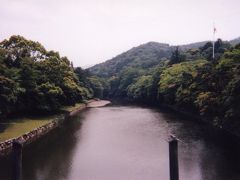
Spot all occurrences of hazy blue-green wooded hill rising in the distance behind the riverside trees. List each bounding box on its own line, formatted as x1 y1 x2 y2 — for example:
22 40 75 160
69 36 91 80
89 42 172 77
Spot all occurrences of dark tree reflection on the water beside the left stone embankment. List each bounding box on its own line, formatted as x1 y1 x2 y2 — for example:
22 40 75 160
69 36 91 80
0 109 86 180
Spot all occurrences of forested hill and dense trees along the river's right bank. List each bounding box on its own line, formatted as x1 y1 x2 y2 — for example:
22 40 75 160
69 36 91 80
90 39 240 132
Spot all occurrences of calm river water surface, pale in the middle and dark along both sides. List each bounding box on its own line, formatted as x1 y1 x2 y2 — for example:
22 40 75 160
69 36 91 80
0 106 240 180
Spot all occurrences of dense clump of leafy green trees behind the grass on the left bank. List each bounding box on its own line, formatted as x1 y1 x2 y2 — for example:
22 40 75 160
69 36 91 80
0 36 94 117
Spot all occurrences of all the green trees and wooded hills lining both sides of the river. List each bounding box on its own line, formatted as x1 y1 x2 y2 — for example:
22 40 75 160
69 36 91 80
0 36 240 135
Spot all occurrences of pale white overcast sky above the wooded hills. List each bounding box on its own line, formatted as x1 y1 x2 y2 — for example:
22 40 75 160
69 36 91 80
0 0 240 67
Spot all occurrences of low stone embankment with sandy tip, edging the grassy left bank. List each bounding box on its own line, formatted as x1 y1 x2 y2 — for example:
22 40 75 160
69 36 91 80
0 100 110 156
